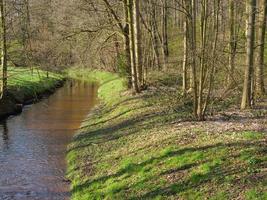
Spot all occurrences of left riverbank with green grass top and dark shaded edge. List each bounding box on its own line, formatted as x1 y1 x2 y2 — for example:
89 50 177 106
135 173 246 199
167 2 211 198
0 68 64 120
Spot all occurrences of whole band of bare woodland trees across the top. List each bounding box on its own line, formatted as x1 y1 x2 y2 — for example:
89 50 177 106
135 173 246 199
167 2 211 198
1 0 267 120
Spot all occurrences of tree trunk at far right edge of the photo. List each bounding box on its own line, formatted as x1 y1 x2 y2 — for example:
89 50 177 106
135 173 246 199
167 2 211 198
256 0 267 96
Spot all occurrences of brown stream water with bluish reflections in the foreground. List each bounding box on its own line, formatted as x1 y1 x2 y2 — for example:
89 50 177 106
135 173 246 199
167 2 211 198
0 81 97 200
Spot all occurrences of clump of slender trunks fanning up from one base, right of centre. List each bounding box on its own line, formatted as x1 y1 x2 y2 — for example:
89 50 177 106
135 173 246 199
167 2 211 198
180 0 221 120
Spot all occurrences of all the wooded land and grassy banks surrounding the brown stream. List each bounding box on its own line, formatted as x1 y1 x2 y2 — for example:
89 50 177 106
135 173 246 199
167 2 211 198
0 0 267 200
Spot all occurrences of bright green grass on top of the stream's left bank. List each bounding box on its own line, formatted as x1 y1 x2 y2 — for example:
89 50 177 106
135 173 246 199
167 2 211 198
8 67 63 97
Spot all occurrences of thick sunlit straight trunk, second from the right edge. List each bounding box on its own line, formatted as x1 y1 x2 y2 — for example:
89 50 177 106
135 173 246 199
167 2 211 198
241 0 256 109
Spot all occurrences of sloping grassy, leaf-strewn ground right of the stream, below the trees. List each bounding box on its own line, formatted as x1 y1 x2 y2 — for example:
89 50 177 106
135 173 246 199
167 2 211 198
67 70 267 200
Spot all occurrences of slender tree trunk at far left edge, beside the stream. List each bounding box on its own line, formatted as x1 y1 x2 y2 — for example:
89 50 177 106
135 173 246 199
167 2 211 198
0 0 7 98
